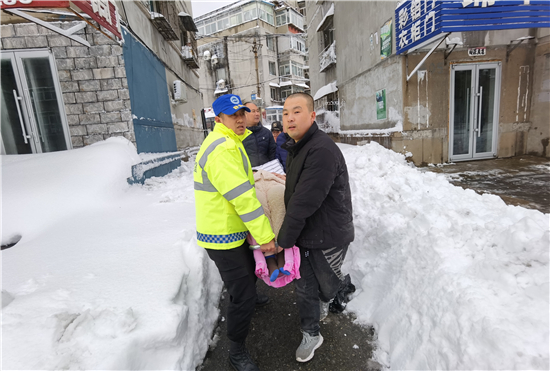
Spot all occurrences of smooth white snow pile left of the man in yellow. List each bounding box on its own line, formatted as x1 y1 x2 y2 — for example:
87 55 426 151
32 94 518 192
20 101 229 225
2 138 221 370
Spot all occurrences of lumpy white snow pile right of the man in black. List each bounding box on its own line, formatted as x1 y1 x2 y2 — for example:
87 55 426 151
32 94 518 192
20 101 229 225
342 143 549 370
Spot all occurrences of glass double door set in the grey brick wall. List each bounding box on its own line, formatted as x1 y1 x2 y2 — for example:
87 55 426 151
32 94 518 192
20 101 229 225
1 51 71 154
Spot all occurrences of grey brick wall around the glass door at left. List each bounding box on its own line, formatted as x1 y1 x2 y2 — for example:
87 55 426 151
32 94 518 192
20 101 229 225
0 22 135 148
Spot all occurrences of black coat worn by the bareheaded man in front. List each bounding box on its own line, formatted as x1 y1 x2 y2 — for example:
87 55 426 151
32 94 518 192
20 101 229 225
278 122 355 249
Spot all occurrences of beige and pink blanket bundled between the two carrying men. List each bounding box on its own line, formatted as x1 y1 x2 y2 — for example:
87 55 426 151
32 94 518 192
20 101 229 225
247 170 300 287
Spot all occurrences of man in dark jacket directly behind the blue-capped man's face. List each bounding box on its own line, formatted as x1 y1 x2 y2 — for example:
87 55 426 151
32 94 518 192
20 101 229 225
243 102 277 167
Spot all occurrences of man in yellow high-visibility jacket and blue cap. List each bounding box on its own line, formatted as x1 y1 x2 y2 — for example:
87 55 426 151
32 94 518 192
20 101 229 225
194 94 281 370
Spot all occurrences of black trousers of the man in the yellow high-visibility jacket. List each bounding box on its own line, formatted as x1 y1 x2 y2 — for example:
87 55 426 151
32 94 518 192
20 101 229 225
206 241 257 343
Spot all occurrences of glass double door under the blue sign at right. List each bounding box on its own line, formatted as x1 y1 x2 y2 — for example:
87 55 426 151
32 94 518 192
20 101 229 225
449 63 500 161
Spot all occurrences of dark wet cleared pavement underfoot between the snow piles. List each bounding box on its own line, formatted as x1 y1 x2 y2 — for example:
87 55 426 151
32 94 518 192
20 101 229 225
197 280 380 371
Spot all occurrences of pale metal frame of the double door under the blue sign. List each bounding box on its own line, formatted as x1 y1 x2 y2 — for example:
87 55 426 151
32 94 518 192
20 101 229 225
449 62 501 161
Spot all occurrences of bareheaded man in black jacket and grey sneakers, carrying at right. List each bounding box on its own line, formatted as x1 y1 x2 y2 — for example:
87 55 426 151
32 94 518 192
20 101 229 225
278 93 354 362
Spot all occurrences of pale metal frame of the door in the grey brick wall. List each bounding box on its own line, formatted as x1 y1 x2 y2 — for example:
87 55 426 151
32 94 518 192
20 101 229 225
0 49 73 154
